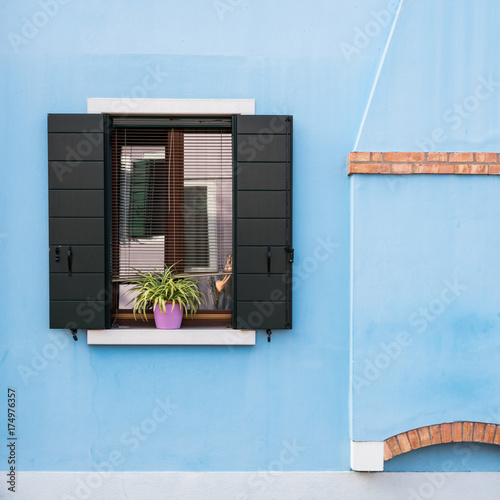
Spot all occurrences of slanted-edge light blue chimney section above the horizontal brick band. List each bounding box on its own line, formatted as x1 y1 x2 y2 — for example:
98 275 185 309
356 0 500 152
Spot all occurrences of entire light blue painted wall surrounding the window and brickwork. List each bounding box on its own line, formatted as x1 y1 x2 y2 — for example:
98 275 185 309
0 0 500 471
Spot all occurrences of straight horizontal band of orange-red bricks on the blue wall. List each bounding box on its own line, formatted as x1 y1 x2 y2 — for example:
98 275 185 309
348 152 500 175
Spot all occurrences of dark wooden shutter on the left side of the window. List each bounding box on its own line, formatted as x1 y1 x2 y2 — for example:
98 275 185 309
48 114 110 329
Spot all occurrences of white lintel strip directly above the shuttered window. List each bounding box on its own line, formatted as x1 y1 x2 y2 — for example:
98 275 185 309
87 97 255 116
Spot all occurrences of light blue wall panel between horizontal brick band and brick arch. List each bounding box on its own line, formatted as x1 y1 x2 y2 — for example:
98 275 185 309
353 175 500 441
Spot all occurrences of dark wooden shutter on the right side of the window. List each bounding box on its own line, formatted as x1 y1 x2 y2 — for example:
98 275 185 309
233 116 293 329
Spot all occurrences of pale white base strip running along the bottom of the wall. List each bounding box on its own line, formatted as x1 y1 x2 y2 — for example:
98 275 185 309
5 472 500 500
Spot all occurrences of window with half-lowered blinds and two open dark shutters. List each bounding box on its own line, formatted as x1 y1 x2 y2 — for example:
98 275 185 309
48 100 293 329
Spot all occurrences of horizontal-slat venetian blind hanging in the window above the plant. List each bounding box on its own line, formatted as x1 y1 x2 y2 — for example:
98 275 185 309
111 117 232 282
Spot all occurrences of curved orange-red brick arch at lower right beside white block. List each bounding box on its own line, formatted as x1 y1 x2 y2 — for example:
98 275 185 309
384 422 500 461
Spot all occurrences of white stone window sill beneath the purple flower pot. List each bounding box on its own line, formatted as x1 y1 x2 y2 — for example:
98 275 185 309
87 327 255 346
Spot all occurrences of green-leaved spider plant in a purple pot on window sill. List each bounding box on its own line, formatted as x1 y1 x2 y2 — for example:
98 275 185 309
126 264 206 330
